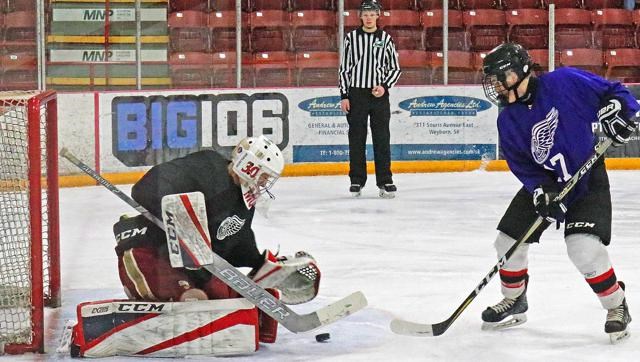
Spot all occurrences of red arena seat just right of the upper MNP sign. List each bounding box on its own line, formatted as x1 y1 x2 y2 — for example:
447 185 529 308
169 10 211 52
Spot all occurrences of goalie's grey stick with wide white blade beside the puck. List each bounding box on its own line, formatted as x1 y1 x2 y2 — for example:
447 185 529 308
60 148 367 333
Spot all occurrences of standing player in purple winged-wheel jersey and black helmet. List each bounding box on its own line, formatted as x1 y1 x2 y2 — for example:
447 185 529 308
482 43 640 343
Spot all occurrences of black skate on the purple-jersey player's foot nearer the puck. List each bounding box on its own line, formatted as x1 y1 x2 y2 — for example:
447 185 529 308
482 275 529 331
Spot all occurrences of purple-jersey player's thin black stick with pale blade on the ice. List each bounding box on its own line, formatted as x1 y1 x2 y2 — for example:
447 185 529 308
391 138 612 337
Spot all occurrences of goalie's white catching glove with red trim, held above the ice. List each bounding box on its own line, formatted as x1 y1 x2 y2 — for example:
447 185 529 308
248 250 321 304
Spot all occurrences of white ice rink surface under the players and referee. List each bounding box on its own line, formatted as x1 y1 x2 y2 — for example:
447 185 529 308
6 171 640 362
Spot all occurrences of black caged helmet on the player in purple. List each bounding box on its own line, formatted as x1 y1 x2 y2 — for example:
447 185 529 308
482 43 535 105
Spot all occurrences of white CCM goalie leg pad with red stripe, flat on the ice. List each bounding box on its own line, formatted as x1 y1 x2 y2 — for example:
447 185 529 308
70 298 258 357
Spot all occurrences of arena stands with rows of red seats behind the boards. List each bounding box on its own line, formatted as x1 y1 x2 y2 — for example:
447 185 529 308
0 0 640 90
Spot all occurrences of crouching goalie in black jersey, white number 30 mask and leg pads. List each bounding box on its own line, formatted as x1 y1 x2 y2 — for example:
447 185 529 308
72 136 320 357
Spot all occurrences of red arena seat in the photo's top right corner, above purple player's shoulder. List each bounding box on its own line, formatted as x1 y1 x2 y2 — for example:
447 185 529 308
592 9 636 49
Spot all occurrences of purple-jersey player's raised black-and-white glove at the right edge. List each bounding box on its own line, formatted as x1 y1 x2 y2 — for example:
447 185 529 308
598 97 636 146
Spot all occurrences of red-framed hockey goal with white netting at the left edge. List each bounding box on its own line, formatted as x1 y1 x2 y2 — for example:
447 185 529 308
0 91 60 354
